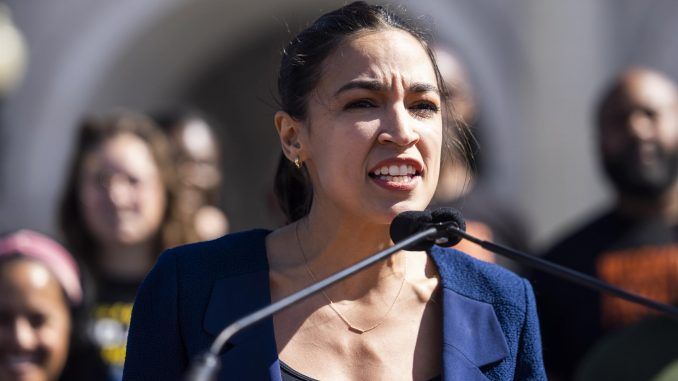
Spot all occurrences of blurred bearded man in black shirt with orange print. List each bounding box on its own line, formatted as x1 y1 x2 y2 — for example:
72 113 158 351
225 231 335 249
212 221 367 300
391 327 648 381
535 68 678 379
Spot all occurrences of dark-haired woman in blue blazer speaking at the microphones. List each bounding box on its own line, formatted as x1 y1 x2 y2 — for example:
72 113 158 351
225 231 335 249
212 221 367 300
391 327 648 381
125 2 545 380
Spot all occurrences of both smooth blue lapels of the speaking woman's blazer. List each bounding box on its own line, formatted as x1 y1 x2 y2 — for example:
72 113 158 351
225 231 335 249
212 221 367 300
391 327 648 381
203 245 509 381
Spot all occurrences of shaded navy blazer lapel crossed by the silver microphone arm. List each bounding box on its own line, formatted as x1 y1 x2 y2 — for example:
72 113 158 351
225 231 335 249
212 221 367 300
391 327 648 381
203 271 281 380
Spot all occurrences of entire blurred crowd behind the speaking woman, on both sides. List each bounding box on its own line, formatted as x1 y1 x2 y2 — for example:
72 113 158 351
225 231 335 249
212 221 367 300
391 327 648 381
0 2 678 380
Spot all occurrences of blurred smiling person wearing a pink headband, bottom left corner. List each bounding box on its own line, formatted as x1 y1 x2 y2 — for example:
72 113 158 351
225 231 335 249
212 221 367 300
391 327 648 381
0 230 104 381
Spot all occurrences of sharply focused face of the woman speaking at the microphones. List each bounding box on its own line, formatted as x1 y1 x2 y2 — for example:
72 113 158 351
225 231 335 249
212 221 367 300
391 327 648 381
300 30 442 224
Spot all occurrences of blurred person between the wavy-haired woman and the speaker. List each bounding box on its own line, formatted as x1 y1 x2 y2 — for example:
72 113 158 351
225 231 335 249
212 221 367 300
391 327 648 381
154 112 228 242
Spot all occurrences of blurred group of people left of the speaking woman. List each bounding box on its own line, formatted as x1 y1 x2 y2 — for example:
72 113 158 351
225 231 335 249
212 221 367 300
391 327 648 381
0 110 228 380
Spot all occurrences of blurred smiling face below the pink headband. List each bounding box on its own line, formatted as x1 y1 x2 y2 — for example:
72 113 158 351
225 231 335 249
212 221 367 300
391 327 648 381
0 259 71 381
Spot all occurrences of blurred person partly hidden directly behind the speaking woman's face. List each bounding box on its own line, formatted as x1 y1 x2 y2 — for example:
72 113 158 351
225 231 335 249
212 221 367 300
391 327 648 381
431 45 527 269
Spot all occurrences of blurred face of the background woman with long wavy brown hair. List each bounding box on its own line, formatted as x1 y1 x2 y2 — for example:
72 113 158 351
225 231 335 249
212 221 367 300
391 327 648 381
79 133 166 247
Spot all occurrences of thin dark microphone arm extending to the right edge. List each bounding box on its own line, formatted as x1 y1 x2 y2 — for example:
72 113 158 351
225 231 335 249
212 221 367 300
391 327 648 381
444 223 678 318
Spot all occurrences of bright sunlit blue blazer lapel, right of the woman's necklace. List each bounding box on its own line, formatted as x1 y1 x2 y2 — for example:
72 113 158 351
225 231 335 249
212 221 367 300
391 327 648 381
443 288 509 380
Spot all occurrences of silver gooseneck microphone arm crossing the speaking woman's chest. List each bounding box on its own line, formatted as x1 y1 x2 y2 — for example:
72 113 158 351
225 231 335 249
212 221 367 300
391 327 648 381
186 225 444 381
